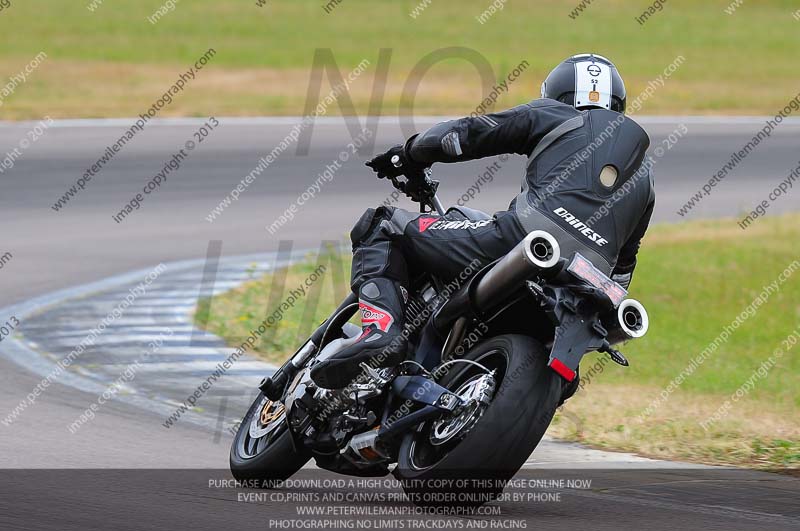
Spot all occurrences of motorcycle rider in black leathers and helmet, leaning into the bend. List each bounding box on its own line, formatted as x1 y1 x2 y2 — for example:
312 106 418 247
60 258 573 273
311 54 655 389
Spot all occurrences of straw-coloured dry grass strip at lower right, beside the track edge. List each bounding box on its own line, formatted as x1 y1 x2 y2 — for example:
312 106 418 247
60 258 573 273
549 382 800 469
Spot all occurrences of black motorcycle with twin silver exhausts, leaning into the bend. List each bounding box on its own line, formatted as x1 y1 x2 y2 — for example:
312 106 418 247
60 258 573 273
230 160 649 505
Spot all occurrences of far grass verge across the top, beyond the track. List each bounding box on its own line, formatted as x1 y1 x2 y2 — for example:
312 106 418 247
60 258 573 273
0 0 799 119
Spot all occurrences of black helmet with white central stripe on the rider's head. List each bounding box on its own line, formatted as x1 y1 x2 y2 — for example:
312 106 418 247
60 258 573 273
542 53 626 113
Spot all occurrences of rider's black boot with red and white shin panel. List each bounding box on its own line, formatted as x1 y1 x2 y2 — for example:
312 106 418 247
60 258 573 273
311 278 408 389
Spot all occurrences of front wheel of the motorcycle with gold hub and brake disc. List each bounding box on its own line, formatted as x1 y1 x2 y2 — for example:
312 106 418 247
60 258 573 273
230 393 310 482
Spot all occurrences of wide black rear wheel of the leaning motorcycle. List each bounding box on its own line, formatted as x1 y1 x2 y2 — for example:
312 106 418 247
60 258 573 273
394 335 564 505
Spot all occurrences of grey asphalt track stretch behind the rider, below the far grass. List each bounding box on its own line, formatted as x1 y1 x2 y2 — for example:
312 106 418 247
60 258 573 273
0 117 800 306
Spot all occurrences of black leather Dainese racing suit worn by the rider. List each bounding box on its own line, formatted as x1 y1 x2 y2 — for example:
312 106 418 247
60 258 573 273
351 99 655 300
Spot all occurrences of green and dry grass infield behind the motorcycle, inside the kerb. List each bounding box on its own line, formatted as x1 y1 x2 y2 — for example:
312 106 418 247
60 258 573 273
197 214 800 469
